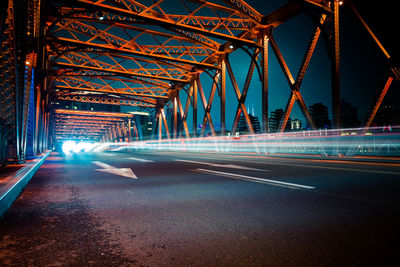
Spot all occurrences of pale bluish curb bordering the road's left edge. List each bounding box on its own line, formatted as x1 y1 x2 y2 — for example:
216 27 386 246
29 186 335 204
0 151 51 217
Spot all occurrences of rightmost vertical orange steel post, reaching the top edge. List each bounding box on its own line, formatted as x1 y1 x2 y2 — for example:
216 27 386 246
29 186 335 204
331 0 340 129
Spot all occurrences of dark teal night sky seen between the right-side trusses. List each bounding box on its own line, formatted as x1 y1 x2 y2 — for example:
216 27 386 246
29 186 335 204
222 0 399 130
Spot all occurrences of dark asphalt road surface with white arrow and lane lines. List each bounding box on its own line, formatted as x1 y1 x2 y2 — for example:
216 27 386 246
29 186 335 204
0 151 400 266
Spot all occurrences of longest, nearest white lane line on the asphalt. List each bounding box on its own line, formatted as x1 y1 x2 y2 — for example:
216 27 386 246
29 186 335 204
193 168 315 189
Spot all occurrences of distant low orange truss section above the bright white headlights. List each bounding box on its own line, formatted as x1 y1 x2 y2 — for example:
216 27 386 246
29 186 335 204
52 109 137 142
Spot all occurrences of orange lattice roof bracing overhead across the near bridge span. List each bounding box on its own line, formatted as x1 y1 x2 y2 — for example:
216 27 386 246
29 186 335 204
43 0 261 111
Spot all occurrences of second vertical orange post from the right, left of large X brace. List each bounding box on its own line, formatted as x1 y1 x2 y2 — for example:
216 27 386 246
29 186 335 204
261 29 269 133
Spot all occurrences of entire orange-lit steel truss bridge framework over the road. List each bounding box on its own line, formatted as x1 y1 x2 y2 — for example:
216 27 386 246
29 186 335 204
0 0 400 163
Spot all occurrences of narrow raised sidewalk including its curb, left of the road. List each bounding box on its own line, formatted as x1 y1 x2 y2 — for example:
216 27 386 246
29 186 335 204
0 151 51 217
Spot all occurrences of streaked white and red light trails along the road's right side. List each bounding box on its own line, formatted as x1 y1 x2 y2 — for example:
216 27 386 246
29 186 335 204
109 126 400 157
